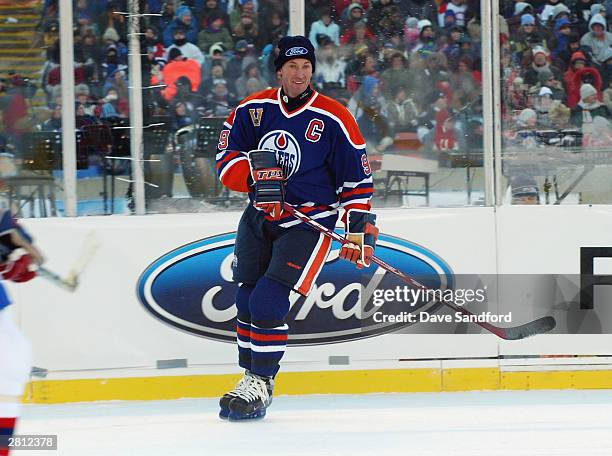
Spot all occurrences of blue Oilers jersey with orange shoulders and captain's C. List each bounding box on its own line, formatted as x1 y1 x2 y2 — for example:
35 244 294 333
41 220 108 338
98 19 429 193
217 89 373 228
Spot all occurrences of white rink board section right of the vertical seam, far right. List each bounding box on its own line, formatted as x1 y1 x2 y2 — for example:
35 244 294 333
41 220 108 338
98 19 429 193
496 205 612 355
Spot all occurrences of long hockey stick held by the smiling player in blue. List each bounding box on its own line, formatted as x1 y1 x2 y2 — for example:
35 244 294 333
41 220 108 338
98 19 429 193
283 203 557 340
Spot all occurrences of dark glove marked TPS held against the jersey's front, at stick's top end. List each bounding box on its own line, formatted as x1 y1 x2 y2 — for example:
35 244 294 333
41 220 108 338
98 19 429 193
249 150 285 220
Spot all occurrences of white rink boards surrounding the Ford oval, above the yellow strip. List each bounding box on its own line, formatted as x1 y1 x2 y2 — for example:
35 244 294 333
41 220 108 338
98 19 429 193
10 206 612 378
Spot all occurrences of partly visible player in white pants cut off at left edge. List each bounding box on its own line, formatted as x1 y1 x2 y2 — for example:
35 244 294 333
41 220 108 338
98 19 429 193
0 210 42 456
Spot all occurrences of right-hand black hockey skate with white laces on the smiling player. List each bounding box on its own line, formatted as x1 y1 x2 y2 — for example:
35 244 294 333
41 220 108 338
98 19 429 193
228 372 274 421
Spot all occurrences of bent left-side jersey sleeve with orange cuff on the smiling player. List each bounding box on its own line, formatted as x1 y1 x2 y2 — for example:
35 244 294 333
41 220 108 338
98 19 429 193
217 108 254 193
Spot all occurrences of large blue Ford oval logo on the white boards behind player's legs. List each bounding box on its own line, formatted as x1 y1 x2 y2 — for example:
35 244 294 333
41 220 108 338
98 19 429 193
138 233 453 345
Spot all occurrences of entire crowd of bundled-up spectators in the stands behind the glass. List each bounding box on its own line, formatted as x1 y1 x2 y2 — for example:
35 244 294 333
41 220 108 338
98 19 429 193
0 0 612 166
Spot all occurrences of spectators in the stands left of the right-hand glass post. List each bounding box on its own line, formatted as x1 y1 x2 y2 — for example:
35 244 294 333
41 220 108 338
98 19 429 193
10 0 482 157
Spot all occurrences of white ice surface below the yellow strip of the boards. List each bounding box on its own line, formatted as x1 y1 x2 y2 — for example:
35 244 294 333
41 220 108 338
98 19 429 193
16 390 612 456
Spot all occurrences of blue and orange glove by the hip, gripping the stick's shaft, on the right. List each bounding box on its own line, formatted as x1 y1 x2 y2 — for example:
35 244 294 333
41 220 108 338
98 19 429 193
340 209 378 269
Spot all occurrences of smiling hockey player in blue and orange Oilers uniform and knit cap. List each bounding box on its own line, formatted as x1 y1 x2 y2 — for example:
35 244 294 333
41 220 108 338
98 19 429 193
217 36 376 420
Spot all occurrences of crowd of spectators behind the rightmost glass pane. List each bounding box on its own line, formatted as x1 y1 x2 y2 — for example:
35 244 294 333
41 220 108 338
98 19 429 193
500 0 612 147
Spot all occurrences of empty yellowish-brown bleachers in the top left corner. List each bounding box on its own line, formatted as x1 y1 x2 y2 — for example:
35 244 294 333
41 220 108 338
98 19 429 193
0 0 48 108
